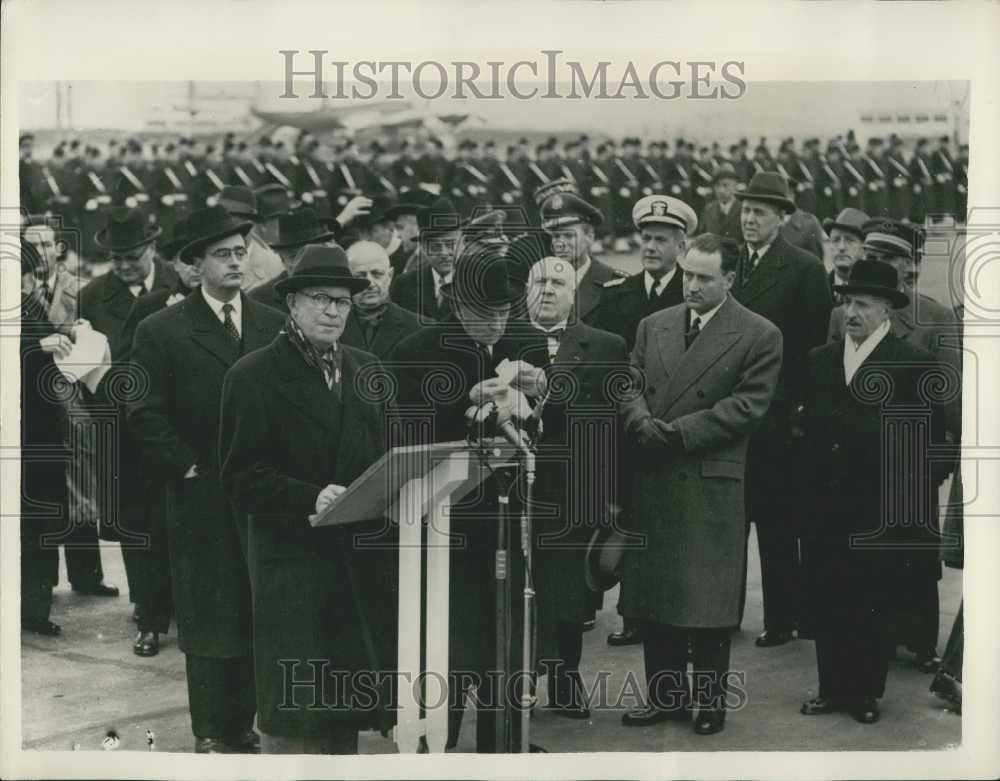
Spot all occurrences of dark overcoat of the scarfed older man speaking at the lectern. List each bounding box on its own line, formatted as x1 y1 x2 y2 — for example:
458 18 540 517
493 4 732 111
219 333 396 736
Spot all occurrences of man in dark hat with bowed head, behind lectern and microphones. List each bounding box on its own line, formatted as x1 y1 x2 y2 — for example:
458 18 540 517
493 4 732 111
388 242 540 753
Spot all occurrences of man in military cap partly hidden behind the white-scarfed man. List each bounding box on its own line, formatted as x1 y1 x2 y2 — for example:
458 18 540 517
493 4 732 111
830 219 962 673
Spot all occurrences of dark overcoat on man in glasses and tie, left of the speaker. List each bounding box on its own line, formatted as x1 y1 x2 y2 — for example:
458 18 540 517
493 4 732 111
128 289 284 658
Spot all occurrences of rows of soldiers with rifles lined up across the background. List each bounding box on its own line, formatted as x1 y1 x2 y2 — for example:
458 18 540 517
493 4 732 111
20 132 968 272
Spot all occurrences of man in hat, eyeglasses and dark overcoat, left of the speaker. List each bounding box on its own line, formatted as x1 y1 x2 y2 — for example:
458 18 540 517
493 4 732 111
128 205 283 753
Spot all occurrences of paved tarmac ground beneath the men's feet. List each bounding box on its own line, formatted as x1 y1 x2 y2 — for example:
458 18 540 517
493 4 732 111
22 237 961 753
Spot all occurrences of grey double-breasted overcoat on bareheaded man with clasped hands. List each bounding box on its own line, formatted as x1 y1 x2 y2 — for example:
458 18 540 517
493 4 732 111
622 296 782 628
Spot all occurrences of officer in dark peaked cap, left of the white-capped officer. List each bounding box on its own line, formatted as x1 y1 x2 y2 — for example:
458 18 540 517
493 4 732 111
541 192 628 325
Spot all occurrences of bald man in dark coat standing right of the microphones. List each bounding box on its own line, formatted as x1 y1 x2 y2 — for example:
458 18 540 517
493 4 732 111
515 257 628 719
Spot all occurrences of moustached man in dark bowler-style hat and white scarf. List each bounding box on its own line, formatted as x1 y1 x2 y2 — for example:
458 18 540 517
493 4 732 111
801 260 948 724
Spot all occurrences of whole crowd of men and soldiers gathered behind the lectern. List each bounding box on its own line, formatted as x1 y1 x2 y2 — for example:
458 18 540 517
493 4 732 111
21 123 964 753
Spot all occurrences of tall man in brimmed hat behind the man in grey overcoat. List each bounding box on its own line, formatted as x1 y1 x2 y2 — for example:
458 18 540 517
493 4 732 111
733 171 832 647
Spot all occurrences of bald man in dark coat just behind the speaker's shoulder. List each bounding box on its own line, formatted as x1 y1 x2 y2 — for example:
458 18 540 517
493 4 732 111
340 241 420 358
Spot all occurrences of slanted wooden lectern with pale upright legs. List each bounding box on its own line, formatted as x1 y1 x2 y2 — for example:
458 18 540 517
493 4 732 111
312 438 517 754
